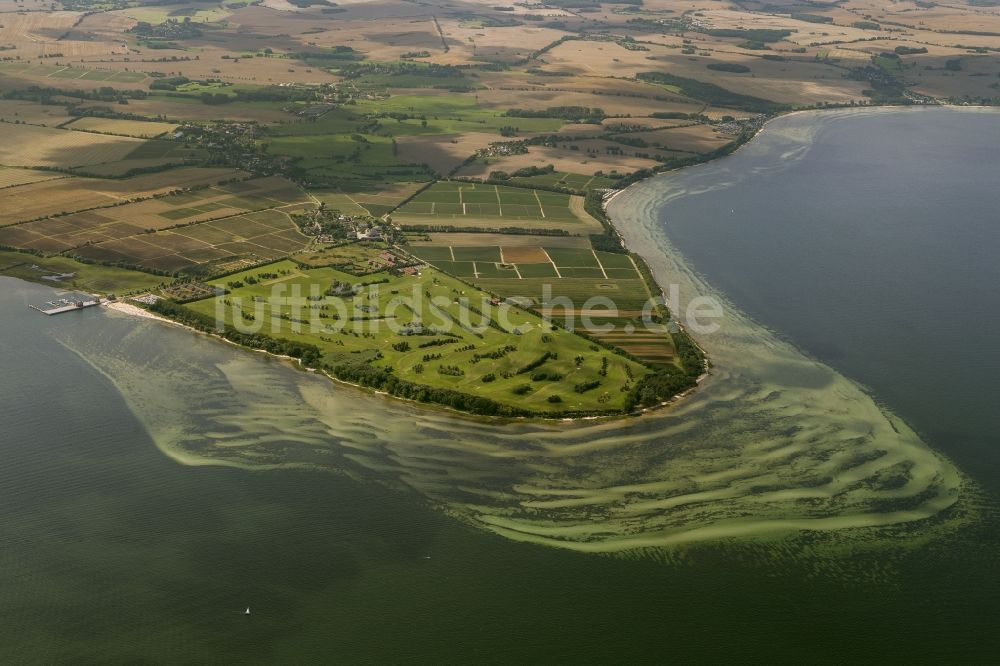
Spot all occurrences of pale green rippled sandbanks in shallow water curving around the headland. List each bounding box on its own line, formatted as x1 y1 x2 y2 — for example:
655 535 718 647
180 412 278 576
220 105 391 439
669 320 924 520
43 106 978 557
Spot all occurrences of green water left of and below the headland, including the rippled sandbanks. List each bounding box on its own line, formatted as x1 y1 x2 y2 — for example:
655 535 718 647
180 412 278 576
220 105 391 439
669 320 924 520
0 106 1000 663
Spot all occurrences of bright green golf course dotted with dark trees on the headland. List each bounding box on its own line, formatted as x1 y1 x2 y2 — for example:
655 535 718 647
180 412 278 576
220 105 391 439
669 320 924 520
188 253 648 412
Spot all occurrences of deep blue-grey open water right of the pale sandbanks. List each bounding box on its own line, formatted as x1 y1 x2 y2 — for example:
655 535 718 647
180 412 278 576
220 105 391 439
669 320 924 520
658 108 1000 488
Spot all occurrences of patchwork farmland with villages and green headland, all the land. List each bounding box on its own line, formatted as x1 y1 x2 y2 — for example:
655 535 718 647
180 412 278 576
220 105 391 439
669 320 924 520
0 2 1000 418
